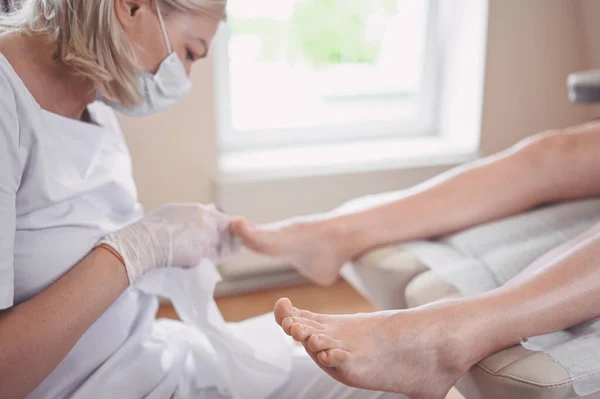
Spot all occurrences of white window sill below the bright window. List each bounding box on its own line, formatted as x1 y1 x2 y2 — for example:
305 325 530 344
218 137 479 183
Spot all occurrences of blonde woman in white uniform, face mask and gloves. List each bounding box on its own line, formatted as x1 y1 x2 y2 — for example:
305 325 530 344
0 0 406 399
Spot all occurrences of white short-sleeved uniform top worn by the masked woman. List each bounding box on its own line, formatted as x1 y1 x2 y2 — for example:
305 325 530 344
0 54 166 398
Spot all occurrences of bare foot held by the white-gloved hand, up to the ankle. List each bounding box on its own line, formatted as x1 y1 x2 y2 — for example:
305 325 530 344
232 219 353 286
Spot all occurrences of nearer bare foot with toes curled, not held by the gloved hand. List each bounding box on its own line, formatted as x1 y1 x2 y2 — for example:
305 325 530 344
275 298 471 399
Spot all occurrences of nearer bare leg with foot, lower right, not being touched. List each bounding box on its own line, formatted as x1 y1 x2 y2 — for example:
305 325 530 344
275 225 600 399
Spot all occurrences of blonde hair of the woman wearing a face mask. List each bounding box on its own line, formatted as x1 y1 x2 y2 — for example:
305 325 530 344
0 0 227 106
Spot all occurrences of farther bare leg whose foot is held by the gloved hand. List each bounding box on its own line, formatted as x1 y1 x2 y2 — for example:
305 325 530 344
233 124 600 285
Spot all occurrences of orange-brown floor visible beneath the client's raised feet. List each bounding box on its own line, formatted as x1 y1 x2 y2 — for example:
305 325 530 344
158 282 463 399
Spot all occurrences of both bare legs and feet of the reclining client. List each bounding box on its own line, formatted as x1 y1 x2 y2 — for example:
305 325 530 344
235 123 600 399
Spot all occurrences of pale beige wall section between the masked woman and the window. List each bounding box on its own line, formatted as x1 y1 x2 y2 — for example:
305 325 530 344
121 61 217 210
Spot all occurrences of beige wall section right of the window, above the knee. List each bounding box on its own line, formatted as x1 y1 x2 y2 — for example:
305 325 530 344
481 0 589 154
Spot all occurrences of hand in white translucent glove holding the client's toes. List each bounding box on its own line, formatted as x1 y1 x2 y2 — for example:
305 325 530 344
98 204 241 285
